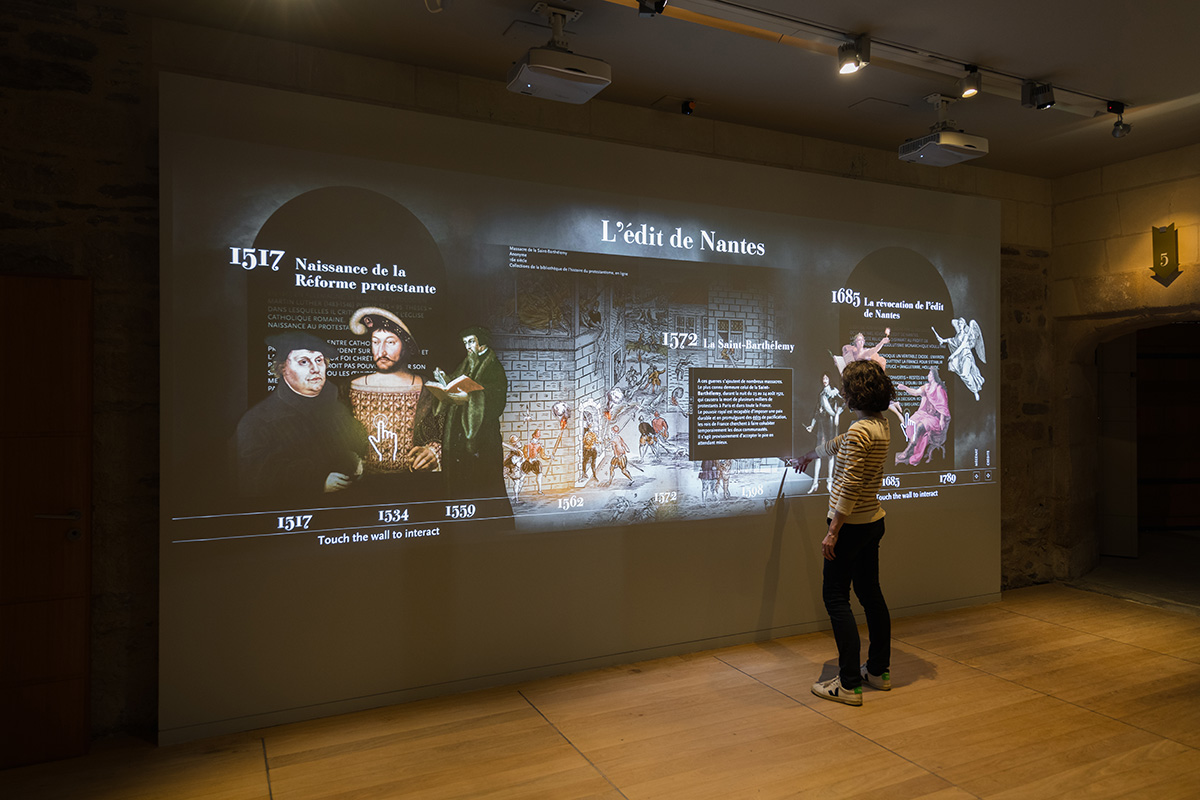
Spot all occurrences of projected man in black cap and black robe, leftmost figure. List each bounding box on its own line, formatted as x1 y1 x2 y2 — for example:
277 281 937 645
236 331 367 498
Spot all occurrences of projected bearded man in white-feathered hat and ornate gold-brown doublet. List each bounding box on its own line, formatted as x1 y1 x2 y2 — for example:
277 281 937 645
350 307 442 475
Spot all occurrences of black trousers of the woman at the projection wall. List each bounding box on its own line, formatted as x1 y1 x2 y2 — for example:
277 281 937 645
821 517 892 688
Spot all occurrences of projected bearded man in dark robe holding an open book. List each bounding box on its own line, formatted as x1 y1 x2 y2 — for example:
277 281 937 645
430 327 511 513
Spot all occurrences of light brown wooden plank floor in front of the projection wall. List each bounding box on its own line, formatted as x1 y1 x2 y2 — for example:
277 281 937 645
0 585 1200 800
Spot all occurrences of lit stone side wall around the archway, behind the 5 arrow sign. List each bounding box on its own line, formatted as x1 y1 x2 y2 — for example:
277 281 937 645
1046 145 1200 578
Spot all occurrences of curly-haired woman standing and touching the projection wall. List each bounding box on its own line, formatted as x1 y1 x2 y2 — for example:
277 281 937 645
797 361 895 705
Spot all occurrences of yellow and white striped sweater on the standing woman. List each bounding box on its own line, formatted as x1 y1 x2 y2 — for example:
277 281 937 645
816 416 892 524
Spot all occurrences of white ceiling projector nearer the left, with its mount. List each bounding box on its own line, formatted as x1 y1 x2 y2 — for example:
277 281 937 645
509 2 612 104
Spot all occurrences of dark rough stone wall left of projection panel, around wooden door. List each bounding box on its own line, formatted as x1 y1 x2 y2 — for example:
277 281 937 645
0 1 158 733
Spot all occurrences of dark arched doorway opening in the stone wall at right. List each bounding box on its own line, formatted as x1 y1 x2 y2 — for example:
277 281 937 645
1082 321 1200 613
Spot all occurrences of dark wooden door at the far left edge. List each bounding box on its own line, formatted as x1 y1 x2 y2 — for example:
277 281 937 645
0 276 91 769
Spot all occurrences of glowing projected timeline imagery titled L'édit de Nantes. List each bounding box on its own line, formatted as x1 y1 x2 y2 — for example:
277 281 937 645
166 122 996 546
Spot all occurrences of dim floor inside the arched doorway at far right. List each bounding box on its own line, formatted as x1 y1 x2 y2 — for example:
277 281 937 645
1067 531 1200 616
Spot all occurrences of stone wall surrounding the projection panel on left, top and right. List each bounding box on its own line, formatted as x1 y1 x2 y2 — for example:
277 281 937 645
0 0 1152 734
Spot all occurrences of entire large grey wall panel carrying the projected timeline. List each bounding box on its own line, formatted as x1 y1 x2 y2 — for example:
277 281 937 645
161 74 1000 740
